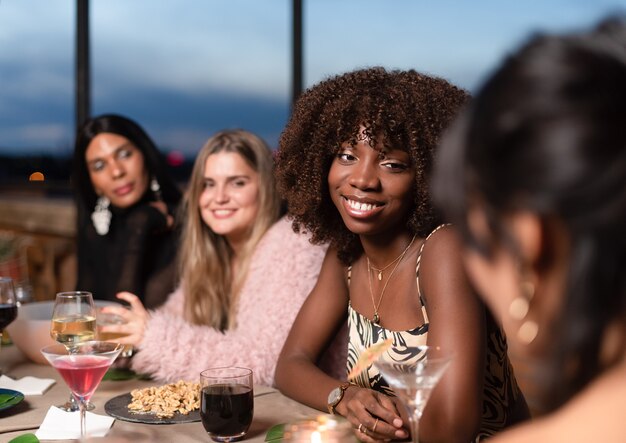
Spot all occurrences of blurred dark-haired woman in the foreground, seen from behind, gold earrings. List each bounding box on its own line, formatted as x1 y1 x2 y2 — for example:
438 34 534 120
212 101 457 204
434 16 626 443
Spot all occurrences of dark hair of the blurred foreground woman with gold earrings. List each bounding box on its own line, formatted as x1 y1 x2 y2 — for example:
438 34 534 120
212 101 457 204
434 16 626 406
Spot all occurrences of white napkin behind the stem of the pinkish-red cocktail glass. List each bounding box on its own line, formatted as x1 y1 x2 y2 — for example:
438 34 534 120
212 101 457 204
35 406 115 440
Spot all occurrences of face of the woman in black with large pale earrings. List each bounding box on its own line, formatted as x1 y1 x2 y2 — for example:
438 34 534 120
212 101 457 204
85 132 149 208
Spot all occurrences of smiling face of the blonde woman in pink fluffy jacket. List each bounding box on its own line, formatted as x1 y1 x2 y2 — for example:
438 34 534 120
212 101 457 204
199 151 259 247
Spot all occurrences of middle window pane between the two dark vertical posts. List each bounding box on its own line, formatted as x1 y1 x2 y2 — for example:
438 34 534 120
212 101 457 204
91 0 291 159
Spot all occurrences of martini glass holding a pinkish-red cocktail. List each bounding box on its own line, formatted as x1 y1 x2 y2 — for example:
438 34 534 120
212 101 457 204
41 341 124 438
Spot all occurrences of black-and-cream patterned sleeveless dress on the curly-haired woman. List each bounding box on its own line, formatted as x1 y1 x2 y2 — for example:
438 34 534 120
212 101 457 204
347 225 525 442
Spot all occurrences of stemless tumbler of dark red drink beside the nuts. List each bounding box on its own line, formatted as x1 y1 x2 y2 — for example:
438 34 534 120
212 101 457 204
200 367 254 442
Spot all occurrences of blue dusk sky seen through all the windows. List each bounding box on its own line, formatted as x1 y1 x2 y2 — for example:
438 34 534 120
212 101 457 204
0 0 626 157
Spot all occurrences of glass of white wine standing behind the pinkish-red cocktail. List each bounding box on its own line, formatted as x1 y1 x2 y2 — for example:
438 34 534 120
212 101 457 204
50 291 96 411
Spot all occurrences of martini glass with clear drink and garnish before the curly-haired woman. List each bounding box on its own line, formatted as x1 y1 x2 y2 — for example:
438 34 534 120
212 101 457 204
374 346 452 443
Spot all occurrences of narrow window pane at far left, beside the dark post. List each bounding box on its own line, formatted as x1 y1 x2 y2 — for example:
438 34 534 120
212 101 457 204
0 0 75 187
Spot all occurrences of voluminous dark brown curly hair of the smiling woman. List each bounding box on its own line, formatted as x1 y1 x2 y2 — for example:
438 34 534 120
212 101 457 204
276 67 469 264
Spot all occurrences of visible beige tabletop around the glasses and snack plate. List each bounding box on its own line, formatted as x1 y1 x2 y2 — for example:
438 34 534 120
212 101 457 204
0 345 323 443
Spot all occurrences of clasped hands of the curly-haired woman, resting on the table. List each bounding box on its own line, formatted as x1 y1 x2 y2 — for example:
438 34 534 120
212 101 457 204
335 385 409 443
